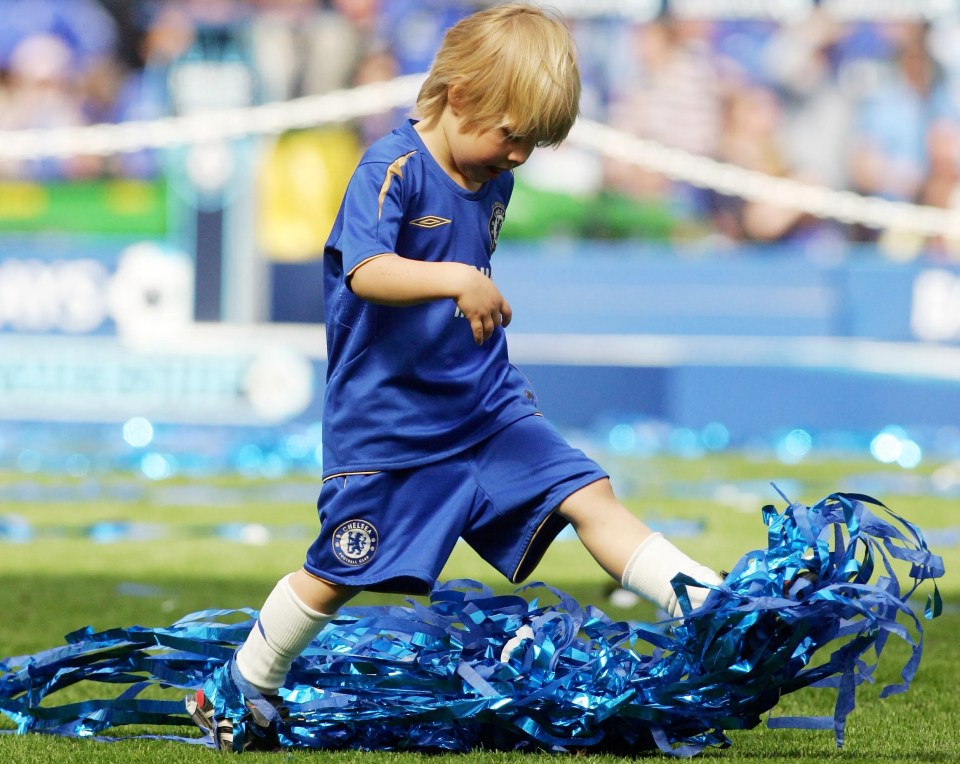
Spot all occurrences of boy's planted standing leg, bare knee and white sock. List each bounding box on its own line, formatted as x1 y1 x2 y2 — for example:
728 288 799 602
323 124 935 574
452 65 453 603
236 570 359 695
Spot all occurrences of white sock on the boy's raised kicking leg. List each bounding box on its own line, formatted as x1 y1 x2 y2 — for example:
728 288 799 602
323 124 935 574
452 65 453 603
622 533 722 617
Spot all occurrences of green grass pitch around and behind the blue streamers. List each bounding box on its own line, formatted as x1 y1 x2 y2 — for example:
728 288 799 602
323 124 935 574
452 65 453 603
0 454 960 764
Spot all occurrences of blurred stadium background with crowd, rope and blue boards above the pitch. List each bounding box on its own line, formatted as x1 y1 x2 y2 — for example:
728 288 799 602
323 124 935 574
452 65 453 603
0 0 960 484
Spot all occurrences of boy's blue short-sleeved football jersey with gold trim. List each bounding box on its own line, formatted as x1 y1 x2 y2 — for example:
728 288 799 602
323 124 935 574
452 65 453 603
323 121 536 477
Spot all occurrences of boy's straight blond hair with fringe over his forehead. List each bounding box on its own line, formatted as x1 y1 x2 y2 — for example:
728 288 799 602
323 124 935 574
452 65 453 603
416 4 580 146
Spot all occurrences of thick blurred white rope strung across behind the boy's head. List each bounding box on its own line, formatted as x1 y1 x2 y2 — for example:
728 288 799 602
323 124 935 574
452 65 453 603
0 74 960 238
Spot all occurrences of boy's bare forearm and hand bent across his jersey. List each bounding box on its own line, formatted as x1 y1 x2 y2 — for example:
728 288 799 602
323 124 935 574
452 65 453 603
350 253 513 345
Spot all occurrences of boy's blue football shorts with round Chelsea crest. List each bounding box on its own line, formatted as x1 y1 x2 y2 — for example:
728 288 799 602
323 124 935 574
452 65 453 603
304 415 607 594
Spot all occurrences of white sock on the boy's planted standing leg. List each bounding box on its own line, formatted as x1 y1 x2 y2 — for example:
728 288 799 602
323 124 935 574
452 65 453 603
236 573 333 695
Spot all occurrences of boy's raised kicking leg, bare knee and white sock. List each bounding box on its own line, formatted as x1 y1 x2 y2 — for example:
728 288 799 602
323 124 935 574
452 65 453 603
558 479 720 615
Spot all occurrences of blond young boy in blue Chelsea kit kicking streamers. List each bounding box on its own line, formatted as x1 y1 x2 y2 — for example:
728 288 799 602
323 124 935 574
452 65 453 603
187 5 719 750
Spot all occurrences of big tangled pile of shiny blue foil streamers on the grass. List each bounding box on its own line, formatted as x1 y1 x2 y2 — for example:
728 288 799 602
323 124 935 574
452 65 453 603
0 493 943 756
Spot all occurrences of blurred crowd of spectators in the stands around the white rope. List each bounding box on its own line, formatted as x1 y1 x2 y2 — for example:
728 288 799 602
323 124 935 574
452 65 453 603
0 0 960 252
